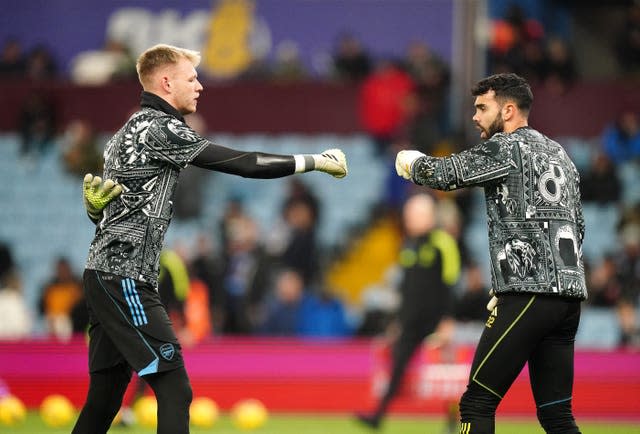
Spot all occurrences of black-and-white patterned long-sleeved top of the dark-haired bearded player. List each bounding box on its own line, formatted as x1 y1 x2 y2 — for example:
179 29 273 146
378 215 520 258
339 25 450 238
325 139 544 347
412 127 587 299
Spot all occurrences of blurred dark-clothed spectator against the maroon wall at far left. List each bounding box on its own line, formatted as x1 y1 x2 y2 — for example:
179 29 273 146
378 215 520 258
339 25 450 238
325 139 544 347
18 92 56 157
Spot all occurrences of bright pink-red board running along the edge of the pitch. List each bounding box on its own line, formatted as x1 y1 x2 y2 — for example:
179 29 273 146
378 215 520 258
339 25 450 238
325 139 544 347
0 338 640 419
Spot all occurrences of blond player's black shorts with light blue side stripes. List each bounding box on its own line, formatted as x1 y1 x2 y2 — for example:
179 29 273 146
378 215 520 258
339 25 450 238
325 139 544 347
83 270 184 375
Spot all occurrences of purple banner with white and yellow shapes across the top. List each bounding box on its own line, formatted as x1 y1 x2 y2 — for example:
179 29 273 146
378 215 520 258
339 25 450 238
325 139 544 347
0 0 453 77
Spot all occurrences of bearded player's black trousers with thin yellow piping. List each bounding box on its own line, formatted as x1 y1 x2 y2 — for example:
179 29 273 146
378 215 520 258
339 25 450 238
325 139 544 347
460 294 580 434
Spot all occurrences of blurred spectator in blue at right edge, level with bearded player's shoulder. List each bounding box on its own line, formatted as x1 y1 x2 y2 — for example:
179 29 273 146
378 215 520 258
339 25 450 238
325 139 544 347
602 110 640 165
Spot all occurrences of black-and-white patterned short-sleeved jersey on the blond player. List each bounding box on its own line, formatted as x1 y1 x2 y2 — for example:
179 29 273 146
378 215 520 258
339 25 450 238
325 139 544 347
86 92 210 286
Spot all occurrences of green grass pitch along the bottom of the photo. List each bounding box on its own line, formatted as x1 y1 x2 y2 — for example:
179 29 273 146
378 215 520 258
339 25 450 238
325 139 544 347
5 412 640 434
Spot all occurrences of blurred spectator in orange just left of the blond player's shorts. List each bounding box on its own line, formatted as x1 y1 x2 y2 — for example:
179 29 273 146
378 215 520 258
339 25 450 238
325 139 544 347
39 257 83 340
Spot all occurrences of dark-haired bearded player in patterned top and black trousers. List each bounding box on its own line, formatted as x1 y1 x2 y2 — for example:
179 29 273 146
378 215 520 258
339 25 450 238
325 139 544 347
396 73 587 434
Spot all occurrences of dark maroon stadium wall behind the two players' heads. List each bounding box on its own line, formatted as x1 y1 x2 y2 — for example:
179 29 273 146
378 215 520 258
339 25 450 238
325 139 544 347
0 80 640 138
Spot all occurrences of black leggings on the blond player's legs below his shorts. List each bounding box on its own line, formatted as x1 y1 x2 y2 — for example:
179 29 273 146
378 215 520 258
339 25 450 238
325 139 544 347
72 365 192 434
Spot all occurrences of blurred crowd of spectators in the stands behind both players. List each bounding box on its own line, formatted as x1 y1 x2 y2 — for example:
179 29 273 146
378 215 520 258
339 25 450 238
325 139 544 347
0 5 640 346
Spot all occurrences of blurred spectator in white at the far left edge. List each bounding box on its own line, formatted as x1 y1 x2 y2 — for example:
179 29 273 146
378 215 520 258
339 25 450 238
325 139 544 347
0 273 33 341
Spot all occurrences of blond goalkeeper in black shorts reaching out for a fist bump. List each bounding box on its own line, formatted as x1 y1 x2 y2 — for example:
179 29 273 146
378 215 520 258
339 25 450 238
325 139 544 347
73 45 347 434
